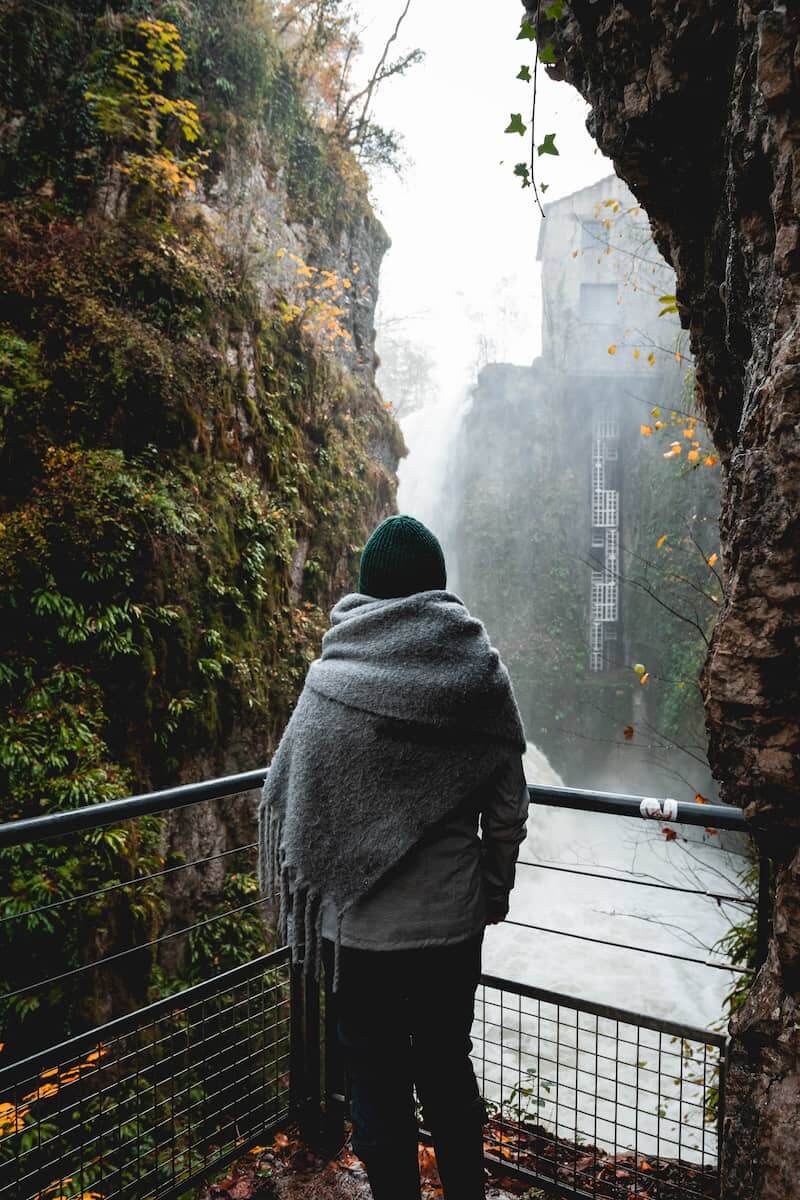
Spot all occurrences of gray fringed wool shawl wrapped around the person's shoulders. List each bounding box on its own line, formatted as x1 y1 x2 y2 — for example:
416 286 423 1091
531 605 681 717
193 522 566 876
259 590 525 991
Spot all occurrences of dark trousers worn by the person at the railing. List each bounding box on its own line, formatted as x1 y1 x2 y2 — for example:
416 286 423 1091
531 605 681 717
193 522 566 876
323 932 487 1200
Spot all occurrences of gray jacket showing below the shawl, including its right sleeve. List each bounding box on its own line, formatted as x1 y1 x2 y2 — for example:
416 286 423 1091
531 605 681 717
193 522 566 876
321 751 528 950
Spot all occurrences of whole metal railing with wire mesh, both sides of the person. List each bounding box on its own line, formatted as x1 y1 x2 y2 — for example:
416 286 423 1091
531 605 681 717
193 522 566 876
0 772 766 1200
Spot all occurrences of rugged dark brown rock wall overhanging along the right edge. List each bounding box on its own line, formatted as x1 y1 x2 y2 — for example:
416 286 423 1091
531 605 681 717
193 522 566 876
525 0 800 1200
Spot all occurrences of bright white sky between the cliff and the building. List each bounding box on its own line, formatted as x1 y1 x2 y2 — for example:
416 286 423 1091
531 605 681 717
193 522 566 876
355 0 613 392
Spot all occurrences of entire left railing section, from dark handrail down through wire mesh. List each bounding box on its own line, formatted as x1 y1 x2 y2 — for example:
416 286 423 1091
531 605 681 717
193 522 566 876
0 776 297 1200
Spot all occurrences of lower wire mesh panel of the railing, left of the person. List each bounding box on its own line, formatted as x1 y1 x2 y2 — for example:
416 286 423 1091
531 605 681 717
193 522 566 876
0 949 290 1200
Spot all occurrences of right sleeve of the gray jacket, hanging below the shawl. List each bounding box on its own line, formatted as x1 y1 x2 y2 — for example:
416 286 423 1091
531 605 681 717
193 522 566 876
481 754 528 910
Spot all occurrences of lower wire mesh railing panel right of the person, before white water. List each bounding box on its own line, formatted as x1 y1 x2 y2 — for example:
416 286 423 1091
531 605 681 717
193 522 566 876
473 976 726 1200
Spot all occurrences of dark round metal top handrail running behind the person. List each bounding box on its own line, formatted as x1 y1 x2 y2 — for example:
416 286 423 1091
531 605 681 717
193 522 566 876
0 767 750 850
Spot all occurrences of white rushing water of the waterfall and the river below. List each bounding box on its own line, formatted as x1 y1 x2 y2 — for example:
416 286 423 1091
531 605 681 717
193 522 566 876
399 396 742 1159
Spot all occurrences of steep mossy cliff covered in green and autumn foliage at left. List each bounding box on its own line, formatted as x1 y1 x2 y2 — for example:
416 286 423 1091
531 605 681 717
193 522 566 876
0 0 403 1043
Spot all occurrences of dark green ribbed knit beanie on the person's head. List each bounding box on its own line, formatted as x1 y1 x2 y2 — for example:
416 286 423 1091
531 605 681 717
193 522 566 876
359 516 447 600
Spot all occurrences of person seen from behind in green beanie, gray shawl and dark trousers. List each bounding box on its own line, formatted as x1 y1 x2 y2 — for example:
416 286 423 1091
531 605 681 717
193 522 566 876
259 516 528 1200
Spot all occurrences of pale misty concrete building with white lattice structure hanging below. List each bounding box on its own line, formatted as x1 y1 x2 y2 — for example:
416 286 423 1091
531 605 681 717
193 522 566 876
536 175 678 672
